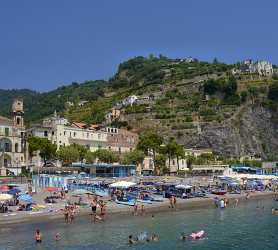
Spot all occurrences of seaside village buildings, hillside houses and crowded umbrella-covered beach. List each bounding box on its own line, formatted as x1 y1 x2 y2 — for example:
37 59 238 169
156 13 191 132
0 60 278 226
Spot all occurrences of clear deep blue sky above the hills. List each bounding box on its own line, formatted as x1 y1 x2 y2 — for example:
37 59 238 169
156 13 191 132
0 0 278 91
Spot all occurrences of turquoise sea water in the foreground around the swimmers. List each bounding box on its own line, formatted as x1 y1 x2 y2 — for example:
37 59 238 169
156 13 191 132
0 200 278 250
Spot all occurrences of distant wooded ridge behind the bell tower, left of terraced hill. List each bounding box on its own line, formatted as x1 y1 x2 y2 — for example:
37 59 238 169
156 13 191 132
0 81 107 123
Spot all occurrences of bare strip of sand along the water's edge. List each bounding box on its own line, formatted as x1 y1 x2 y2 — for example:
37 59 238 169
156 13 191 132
0 192 277 226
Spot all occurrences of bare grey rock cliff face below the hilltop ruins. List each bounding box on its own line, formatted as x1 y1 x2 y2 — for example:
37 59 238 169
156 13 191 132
194 105 278 159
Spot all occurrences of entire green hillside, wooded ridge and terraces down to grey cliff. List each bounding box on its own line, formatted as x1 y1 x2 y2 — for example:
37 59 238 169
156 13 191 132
0 56 278 159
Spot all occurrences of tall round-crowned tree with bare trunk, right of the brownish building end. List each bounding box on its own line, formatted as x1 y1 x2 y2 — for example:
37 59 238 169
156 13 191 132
137 132 163 175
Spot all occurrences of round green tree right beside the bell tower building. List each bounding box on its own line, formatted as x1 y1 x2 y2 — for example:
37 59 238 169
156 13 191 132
28 137 57 164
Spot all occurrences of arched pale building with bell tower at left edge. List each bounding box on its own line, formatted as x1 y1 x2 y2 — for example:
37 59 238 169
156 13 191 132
0 99 28 175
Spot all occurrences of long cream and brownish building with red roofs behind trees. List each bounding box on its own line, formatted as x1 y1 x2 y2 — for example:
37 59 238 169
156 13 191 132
28 117 138 153
